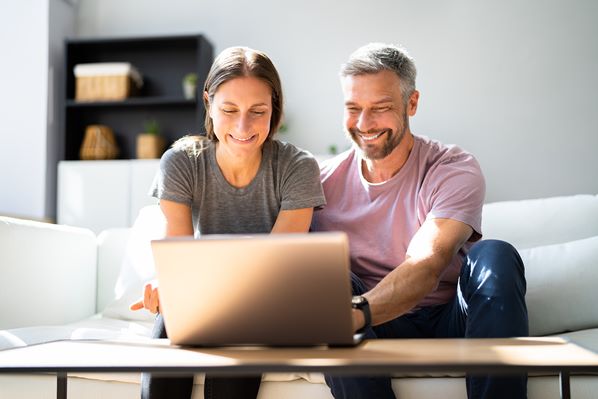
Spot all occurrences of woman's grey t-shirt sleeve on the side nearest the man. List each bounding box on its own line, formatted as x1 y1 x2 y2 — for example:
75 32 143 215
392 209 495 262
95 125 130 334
280 147 326 210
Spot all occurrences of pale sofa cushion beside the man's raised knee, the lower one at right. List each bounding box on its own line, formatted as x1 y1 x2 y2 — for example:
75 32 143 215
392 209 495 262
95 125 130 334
520 236 598 335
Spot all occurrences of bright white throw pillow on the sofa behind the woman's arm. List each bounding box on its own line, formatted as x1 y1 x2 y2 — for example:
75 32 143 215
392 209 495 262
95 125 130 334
102 205 166 321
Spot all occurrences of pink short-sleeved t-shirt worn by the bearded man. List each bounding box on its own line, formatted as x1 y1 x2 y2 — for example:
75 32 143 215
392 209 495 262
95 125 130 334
312 136 486 307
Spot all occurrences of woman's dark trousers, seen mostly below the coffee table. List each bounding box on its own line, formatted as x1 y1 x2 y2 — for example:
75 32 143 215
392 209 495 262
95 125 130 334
141 315 261 399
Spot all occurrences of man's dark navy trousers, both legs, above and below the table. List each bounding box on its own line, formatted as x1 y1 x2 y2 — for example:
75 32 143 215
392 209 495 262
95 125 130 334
326 240 529 399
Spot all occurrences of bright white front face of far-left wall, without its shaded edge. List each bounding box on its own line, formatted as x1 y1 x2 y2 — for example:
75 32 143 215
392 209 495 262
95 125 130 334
0 0 48 218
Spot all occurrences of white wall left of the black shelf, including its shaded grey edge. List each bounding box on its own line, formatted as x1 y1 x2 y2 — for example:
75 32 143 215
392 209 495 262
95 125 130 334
0 0 75 219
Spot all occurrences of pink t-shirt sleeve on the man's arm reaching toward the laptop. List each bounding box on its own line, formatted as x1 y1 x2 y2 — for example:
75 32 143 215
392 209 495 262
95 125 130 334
420 153 486 241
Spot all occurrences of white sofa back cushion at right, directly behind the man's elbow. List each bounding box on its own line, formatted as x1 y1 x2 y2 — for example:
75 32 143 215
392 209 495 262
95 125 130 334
482 195 598 249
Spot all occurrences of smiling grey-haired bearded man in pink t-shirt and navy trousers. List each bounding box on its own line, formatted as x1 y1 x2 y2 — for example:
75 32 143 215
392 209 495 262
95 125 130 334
312 44 528 398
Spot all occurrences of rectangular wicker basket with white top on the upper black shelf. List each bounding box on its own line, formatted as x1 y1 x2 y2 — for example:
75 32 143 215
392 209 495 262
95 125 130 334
74 63 143 101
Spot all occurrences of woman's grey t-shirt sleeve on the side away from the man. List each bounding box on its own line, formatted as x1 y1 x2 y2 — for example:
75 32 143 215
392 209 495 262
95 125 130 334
149 148 193 206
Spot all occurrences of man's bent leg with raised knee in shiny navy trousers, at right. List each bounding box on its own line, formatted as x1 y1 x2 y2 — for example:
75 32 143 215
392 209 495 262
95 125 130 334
437 240 529 399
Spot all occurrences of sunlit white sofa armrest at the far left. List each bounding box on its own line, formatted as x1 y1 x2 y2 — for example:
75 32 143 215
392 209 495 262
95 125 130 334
0 216 97 329
